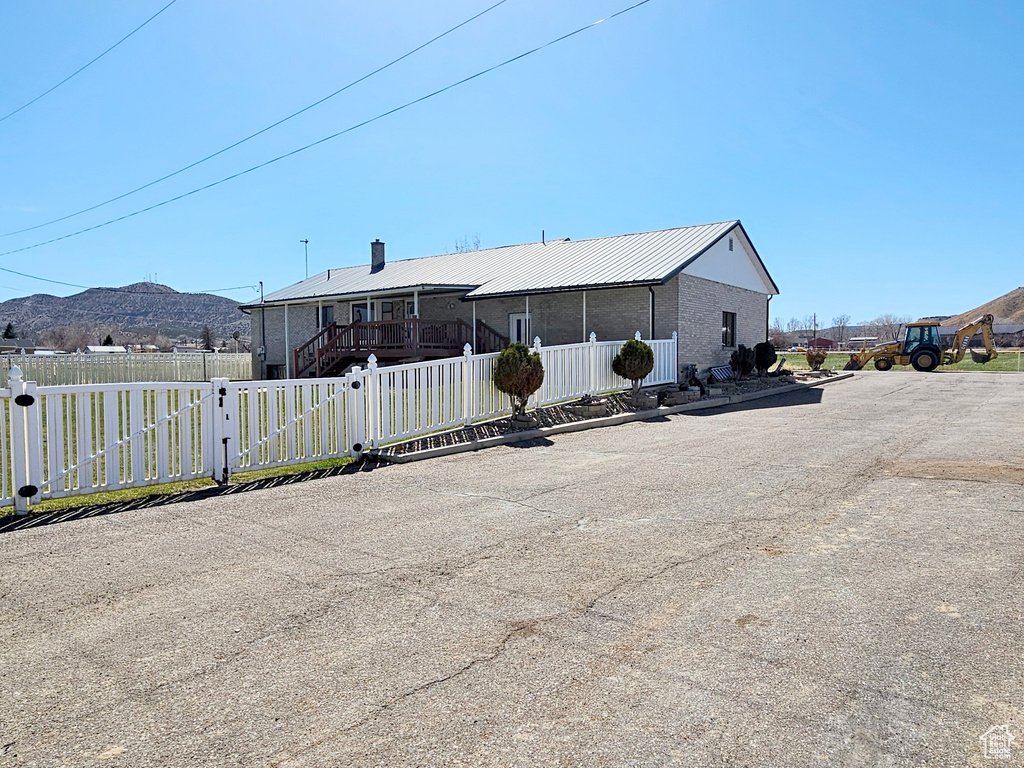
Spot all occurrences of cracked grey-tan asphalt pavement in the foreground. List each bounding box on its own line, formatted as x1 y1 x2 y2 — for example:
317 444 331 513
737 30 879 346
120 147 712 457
0 372 1024 768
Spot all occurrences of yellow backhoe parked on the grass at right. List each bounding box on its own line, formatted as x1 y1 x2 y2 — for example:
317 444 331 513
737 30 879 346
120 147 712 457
846 314 999 371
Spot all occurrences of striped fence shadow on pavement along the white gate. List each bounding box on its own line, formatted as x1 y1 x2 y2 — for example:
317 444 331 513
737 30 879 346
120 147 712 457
0 459 380 534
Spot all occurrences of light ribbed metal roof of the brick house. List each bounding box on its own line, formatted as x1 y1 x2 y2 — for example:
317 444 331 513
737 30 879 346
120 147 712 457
248 220 778 306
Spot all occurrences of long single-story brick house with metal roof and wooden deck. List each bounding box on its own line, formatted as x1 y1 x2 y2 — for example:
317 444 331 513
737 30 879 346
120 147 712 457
242 220 778 378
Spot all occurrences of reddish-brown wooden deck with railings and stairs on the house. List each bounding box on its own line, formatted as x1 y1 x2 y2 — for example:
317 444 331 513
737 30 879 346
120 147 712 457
293 318 508 378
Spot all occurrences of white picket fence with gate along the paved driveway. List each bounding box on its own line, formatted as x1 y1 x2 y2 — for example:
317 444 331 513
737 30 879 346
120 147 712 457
0 334 677 512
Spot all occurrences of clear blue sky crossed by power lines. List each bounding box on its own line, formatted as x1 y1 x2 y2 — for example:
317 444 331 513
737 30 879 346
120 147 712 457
0 0 1024 322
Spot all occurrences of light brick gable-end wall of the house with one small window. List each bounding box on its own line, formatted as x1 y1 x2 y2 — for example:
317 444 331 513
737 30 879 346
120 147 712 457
678 273 768 368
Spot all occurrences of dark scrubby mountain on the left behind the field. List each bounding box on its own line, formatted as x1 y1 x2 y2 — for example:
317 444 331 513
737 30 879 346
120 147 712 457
0 283 249 343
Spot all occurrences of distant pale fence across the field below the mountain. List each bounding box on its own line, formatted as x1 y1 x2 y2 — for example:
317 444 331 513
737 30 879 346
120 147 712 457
0 352 253 387
